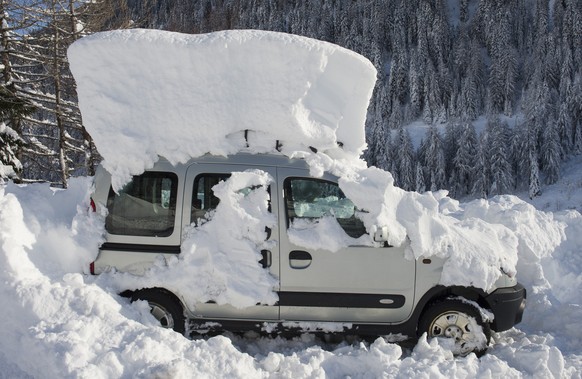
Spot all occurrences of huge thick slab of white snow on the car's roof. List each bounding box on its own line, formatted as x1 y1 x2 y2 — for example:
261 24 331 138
68 29 376 190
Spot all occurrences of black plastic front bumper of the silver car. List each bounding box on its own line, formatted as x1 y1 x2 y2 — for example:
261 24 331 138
485 283 527 332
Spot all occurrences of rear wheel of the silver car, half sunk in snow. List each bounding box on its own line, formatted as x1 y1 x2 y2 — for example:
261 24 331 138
131 289 186 335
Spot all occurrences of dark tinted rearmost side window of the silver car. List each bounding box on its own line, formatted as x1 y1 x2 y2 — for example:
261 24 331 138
105 172 178 237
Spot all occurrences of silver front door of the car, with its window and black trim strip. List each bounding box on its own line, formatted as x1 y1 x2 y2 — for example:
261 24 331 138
278 168 415 323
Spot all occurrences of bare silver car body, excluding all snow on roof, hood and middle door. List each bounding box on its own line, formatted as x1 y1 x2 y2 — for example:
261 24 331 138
90 153 526 355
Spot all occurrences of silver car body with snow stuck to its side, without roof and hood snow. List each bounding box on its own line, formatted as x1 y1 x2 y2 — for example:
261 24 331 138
91 154 526 355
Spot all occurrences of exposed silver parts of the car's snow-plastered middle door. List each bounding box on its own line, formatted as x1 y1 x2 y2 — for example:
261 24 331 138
182 163 279 320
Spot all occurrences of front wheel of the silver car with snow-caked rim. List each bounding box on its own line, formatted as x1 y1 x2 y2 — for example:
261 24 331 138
418 299 491 357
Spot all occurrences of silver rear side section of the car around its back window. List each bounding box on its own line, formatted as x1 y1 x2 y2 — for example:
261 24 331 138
93 161 185 275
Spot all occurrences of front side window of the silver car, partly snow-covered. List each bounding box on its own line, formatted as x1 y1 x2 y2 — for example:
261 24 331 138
284 178 366 238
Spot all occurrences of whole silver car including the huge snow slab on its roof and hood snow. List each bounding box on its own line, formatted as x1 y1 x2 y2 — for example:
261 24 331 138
68 30 526 354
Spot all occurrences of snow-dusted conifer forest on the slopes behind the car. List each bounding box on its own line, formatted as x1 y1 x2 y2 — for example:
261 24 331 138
0 0 582 197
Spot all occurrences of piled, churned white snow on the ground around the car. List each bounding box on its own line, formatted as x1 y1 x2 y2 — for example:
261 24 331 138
0 179 582 378
